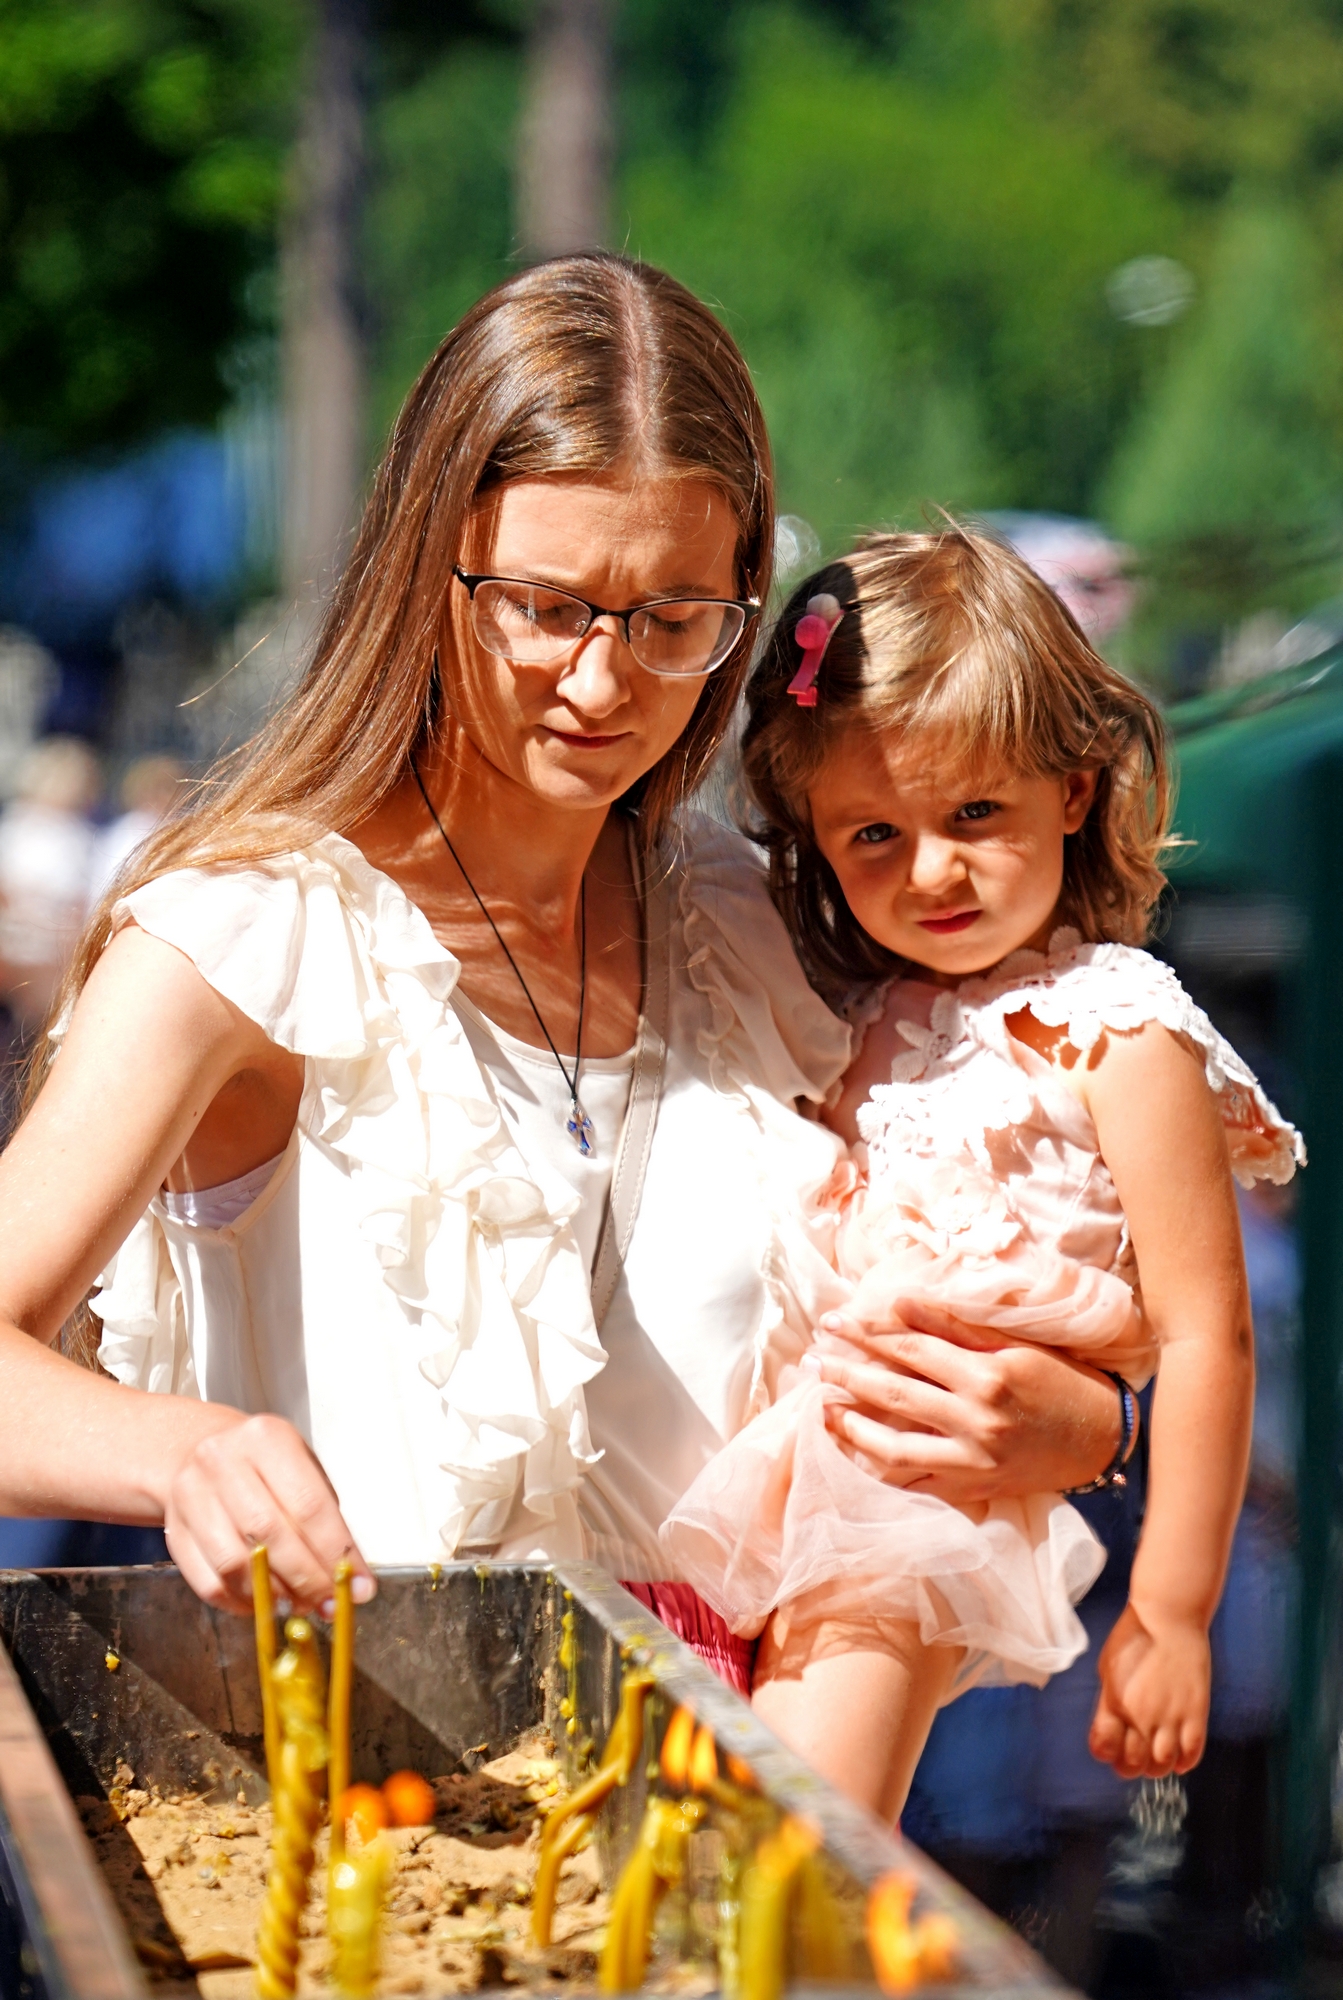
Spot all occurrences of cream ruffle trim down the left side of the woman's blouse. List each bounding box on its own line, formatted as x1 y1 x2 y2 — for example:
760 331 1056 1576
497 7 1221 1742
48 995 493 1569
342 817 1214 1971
94 834 606 1554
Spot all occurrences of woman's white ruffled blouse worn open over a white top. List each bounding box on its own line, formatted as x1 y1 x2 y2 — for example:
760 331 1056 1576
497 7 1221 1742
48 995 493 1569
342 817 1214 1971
92 816 849 1580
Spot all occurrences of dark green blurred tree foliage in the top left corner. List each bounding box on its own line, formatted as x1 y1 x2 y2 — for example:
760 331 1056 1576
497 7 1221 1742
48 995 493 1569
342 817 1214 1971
0 0 304 450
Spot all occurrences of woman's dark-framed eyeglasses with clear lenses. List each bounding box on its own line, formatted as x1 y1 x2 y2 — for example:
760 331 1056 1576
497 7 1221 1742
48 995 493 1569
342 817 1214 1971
452 564 759 678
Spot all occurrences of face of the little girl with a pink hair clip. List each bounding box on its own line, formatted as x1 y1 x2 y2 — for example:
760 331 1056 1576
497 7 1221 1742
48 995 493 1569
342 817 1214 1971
809 730 1095 986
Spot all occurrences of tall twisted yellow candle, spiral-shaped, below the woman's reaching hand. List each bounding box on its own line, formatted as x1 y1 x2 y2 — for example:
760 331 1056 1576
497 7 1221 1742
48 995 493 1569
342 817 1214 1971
256 1618 328 2000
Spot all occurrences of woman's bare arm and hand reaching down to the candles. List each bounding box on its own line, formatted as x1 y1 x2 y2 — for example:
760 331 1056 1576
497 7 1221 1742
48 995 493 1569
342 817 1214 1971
0 928 370 1610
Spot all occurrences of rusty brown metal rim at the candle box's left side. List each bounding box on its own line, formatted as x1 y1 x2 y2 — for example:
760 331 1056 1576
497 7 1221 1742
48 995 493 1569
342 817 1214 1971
0 1616 148 2000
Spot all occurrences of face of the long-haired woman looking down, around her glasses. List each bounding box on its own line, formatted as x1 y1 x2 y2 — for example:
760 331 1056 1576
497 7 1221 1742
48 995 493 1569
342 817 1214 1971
448 474 737 810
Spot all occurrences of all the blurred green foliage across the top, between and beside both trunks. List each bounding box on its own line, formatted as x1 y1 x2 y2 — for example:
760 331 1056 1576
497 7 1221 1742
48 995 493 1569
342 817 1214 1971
0 0 1343 664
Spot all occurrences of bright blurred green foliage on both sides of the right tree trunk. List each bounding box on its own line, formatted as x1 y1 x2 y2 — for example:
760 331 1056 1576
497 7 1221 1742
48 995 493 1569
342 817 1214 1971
359 0 1343 666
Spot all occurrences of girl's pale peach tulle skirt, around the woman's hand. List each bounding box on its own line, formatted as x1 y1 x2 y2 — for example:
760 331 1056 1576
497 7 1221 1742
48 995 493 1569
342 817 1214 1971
662 1218 1127 1694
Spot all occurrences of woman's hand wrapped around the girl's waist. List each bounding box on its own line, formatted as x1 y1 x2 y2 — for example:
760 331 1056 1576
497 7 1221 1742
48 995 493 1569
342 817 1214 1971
813 1300 1121 1504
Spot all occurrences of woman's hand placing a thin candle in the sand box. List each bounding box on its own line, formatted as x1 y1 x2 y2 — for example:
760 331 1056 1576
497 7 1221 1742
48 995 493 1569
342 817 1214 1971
164 1416 376 1616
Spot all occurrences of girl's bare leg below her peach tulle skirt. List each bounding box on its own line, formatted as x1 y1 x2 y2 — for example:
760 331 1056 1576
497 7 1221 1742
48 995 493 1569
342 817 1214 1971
751 1620 961 1824
